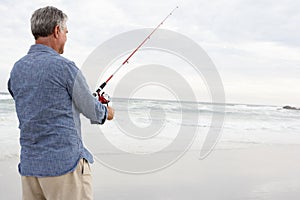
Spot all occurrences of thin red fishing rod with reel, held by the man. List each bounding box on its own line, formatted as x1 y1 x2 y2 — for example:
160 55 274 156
93 6 178 104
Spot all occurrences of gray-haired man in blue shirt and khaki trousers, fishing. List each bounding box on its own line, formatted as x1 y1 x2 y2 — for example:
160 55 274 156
8 7 114 200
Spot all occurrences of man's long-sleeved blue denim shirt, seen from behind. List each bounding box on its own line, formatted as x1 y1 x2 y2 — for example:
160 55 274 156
8 44 107 177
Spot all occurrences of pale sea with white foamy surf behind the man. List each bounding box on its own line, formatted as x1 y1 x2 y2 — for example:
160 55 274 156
0 93 300 160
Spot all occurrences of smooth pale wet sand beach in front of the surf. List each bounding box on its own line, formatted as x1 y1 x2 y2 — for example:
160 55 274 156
0 145 300 200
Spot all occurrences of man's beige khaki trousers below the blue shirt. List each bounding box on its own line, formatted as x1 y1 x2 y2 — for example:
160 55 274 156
22 159 93 200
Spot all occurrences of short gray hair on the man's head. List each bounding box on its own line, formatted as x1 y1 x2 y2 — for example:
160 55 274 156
30 6 68 39
